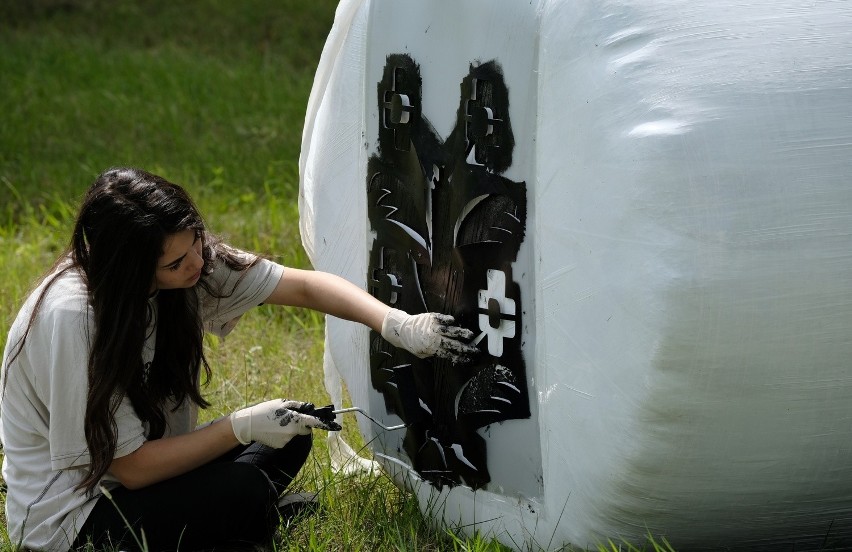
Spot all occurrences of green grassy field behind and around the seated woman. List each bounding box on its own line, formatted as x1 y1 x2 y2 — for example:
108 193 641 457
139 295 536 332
0 0 680 551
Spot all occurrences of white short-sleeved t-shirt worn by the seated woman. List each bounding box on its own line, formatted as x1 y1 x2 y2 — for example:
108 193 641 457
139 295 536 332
0 252 284 551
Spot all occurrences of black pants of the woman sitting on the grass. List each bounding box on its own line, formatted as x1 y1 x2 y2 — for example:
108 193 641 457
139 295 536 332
74 435 311 552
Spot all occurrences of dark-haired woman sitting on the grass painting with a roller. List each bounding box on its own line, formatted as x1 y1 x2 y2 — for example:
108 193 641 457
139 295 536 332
0 168 475 551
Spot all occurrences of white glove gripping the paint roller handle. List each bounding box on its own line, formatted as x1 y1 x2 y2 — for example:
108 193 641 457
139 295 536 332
230 399 340 448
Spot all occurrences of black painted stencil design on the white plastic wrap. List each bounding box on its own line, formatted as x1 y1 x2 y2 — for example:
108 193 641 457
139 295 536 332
367 54 530 488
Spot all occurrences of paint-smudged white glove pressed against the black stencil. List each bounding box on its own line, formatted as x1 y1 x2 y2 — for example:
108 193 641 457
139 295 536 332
382 309 479 363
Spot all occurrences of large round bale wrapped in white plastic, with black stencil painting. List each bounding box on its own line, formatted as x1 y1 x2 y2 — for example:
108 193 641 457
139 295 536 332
301 0 852 549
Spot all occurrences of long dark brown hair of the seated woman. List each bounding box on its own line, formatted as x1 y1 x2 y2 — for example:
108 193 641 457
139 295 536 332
6 168 257 492
